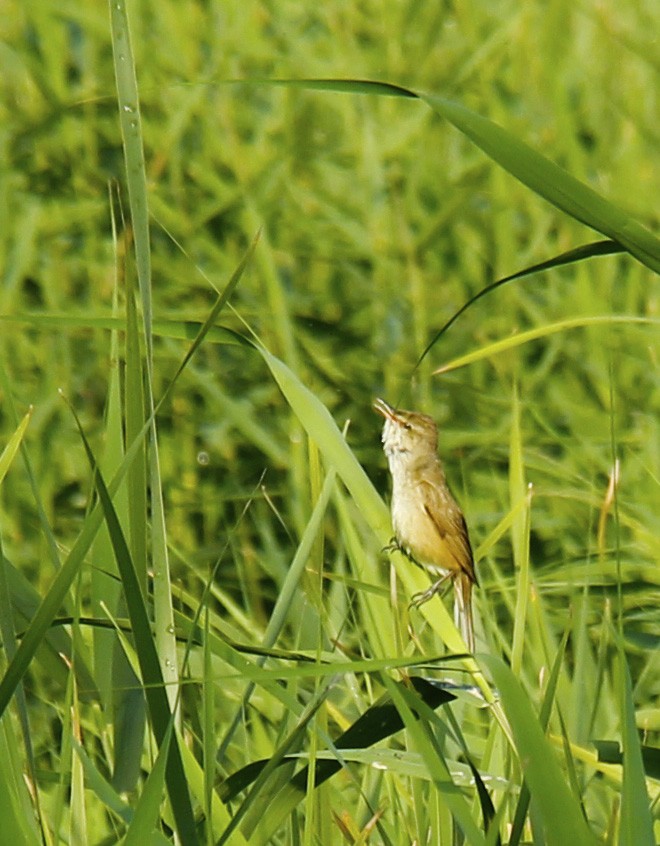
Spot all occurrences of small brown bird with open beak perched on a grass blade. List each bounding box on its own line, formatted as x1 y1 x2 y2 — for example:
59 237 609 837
373 399 478 652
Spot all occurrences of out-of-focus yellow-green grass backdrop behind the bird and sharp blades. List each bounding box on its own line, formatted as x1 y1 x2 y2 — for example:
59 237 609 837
0 0 660 844
